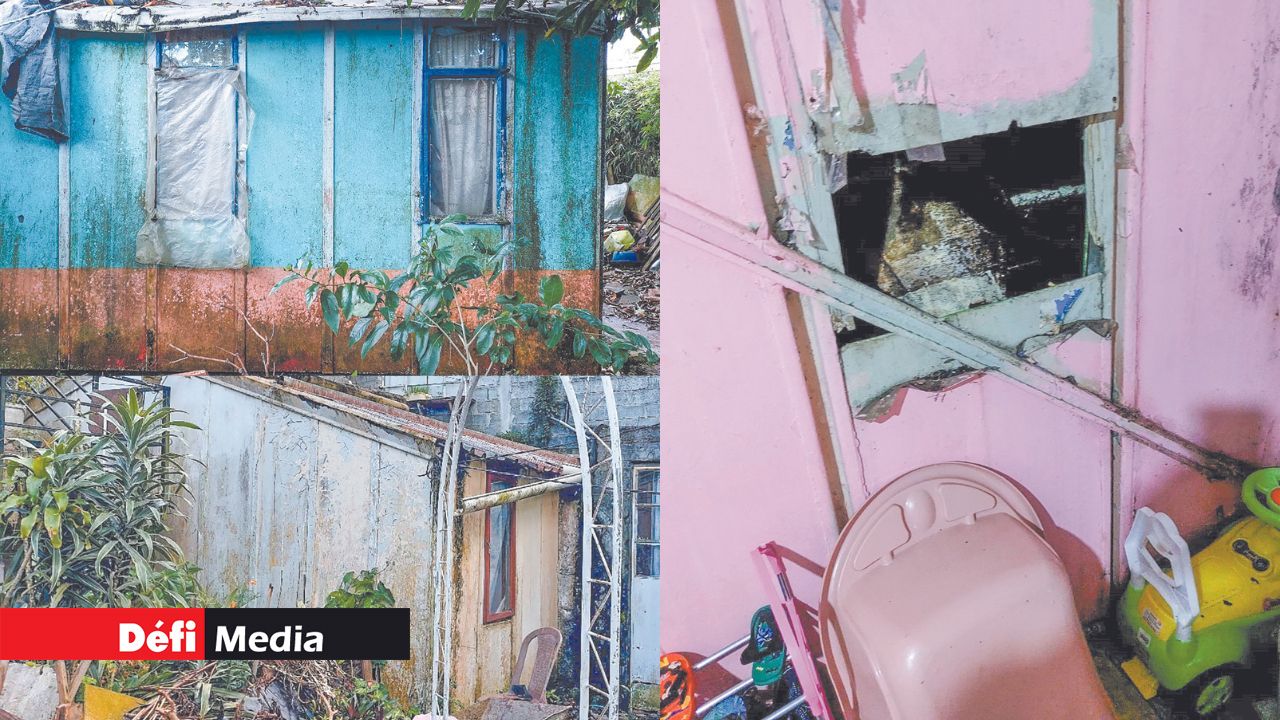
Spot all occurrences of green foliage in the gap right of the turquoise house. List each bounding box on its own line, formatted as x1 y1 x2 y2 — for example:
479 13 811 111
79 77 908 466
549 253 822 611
604 70 662 182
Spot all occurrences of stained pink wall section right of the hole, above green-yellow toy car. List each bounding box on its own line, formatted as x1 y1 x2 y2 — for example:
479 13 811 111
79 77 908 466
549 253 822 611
1120 1 1280 530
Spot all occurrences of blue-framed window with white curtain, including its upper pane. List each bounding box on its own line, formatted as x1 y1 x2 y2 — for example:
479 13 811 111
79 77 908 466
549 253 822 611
424 26 507 219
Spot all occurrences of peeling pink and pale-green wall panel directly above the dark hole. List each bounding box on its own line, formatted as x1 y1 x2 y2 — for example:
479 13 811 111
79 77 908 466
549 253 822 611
808 0 1119 155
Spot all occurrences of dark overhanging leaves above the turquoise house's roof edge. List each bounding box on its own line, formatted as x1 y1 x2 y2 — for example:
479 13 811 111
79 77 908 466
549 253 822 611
462 0 660 70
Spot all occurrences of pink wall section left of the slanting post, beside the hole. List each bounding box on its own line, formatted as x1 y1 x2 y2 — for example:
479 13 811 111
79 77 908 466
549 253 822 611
662 3 840 679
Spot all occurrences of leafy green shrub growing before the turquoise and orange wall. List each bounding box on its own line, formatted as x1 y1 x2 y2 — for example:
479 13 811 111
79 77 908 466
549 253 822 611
273 215 658 375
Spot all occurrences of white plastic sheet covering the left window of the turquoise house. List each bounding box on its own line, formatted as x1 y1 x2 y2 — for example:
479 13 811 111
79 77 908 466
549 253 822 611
137 68 248 268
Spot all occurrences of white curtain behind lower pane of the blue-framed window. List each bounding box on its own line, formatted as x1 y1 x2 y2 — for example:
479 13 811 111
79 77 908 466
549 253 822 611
428 78 497 217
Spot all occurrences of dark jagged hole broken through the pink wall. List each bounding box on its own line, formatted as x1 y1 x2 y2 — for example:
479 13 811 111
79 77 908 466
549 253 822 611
833 120 1087 342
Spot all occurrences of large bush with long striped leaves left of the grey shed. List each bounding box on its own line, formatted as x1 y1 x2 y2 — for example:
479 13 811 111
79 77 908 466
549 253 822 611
0 392 198 607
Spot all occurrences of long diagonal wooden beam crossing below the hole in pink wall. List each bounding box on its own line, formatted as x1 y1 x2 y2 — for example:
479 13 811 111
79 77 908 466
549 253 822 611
663 192 1248 479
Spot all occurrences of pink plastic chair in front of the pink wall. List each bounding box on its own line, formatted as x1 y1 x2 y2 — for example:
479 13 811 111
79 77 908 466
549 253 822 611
819 462 1115 720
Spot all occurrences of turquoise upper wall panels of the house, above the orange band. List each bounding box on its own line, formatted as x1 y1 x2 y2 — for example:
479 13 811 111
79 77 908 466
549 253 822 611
0 20 603 270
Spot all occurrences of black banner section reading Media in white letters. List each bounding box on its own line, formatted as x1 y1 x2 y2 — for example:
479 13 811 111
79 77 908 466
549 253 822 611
204 607 410 660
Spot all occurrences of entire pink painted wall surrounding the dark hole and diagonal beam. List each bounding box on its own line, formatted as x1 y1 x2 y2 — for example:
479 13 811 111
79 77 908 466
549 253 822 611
662 0 1280 707
